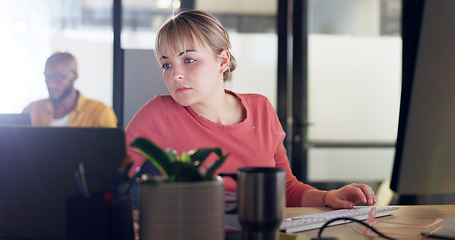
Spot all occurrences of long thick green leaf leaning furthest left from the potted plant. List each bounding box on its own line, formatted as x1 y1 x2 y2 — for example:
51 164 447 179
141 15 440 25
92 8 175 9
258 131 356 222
131 138 172 177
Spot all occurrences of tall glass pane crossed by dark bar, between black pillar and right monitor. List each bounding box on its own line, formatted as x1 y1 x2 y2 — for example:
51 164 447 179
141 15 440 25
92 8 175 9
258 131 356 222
306 0 402 182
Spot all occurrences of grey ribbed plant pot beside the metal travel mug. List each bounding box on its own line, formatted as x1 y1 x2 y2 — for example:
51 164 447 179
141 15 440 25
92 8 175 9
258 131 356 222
139 180 224 240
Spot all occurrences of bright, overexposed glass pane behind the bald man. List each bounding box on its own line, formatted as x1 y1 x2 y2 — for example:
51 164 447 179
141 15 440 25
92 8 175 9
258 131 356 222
0 0 112 113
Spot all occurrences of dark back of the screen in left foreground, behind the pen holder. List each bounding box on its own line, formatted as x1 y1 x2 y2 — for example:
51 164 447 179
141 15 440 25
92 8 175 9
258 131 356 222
0 126 126 240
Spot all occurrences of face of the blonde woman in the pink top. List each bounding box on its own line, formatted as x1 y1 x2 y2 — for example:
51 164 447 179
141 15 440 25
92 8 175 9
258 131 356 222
160 43 229 106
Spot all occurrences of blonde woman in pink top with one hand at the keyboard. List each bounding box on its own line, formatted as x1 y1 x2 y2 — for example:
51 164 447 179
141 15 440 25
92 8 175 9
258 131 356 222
126 10 376 209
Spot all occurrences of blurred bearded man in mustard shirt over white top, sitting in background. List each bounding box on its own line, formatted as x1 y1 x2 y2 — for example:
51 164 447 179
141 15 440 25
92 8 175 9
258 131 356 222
23 52 117 127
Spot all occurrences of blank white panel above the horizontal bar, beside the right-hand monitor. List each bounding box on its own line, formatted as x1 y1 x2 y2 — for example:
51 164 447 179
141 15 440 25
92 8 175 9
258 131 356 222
308 34 401 142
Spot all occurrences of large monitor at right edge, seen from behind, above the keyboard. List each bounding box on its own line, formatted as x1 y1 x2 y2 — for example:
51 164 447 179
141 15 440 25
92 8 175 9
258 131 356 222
390 0 455 202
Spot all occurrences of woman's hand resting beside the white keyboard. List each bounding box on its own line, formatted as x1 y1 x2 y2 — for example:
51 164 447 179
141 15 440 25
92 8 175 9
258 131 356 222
323 183 376 209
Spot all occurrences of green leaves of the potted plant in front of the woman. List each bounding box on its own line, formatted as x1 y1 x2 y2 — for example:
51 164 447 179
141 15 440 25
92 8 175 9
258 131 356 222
131 138 229 182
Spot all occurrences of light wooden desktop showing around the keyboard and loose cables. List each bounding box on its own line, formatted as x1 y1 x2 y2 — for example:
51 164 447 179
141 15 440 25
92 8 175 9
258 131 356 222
286 205 455 240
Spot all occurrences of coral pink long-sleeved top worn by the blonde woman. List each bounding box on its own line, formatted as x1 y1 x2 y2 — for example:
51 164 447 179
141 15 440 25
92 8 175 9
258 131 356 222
126 92 313 207
